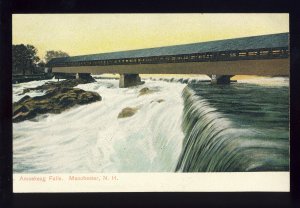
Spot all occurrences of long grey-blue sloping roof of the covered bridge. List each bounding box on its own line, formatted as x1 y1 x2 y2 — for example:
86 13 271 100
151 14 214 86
47 33 289 66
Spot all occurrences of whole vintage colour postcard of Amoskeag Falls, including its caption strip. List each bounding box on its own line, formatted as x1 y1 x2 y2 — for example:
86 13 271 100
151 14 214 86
12 13 290 193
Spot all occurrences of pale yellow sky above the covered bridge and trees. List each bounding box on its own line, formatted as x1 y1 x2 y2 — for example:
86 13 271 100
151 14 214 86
12 13 289 58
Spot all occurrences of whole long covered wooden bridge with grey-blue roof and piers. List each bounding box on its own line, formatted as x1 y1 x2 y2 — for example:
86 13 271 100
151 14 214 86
47 33 290 87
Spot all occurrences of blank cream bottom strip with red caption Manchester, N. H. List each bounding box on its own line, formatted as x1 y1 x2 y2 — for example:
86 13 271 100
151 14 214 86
13 172 290 193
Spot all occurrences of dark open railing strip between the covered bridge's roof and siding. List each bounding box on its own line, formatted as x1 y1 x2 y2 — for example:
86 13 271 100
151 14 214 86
49 47 289 67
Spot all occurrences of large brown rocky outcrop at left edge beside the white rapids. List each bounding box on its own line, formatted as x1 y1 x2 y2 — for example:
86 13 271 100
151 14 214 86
13 85 101 122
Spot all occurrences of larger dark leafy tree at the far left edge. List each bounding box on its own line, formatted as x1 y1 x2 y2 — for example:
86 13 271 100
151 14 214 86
12 44 40 75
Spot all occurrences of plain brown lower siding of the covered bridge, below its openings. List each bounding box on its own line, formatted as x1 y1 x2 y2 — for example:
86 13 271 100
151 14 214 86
52 58 290 76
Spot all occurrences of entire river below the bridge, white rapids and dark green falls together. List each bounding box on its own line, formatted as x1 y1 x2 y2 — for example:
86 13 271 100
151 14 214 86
13 75 289 173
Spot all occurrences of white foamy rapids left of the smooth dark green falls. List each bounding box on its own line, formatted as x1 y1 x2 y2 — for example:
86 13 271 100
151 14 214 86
13 79 185 173
